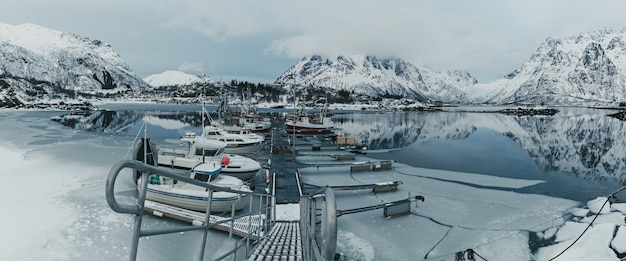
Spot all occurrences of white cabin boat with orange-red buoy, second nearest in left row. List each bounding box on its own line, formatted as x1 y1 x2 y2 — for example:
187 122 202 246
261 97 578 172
157 131 261 180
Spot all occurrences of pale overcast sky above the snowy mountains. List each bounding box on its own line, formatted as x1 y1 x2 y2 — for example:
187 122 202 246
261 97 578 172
0 0 626 83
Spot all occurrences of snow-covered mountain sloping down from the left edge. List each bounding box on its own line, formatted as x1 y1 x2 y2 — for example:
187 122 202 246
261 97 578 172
0 23 150 107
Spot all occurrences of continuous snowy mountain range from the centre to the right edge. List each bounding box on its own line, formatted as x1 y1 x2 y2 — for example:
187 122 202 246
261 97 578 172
276 28 626 105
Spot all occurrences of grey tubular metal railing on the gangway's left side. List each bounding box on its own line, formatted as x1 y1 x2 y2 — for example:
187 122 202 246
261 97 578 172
105 160 272 260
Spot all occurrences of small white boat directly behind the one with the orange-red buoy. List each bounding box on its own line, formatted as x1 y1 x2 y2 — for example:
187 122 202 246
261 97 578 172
202 126 265 153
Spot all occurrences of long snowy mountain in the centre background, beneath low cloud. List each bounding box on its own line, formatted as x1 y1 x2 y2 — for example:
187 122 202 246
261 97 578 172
276 55 476 101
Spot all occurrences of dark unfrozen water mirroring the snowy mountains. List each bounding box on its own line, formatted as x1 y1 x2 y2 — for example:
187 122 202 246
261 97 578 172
56 105 626 201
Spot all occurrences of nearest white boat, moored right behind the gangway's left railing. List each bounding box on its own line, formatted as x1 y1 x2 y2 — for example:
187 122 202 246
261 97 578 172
138 163 252 212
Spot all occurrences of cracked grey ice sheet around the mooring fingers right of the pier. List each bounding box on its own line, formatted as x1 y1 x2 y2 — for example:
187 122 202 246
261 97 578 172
301 159 579 260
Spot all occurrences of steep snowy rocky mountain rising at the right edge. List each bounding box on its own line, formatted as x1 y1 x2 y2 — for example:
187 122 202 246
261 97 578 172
469 28 626 105
